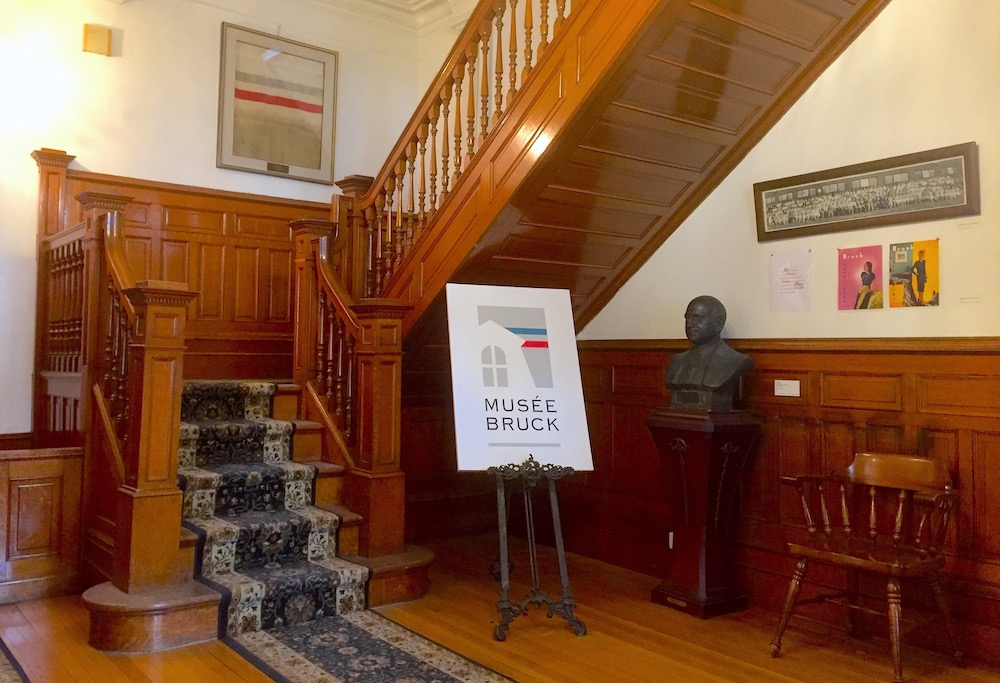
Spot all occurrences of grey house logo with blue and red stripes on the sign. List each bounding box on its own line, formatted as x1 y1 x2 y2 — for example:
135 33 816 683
477 306 553 389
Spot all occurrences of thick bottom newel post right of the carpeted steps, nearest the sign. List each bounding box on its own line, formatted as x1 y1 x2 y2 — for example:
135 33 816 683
349 299 411 557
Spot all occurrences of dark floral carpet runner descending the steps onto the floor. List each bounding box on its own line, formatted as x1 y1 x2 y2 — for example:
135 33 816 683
178 381 508 683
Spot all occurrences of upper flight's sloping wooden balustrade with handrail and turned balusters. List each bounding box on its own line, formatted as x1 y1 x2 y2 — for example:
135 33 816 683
341 0 585 298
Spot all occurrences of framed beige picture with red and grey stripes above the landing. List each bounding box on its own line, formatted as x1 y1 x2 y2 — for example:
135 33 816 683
216 23 337 184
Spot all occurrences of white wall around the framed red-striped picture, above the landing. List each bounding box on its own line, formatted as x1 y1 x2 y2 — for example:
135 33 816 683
0 0 424 433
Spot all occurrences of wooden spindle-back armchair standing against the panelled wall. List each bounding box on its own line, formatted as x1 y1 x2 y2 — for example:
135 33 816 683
771 453 962 683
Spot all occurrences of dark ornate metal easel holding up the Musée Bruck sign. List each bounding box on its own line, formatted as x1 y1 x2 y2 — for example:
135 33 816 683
487 455 587 640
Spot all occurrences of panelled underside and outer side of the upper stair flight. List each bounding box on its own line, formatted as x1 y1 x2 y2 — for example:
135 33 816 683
391 0 888 371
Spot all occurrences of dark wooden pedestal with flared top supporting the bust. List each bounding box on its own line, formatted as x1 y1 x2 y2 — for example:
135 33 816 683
646 408 761 619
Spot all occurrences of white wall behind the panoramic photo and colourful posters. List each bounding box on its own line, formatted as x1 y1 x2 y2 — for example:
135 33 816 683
580 0 1000 339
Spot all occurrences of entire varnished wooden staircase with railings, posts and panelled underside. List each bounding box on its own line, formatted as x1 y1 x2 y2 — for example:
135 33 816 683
27 0 888 650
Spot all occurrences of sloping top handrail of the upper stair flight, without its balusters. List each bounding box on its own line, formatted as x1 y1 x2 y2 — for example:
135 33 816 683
358 0 506 210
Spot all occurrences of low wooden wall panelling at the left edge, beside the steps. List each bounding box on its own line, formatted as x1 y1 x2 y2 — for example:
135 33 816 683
0 448 83 603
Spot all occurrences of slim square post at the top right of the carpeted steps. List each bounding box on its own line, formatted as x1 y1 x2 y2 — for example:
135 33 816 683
289 218 337 386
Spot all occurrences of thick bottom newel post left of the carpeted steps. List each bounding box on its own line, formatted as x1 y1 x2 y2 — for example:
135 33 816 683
112 281 196 593
